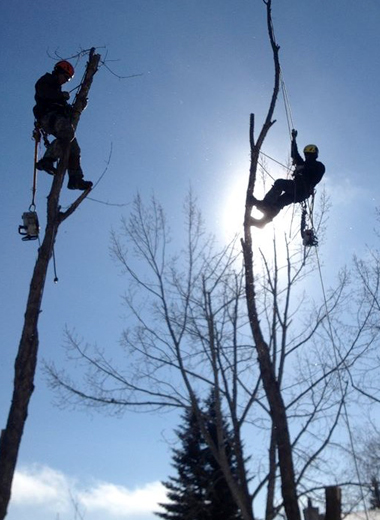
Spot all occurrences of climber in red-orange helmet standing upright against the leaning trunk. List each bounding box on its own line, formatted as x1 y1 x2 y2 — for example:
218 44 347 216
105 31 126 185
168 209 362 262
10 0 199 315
33 60 92 190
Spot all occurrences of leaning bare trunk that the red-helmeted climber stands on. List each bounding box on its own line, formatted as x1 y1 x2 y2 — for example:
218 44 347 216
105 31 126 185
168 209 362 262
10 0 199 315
0 49 100 520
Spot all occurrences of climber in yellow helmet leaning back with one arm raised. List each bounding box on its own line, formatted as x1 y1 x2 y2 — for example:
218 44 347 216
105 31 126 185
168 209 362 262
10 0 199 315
250 130 325 227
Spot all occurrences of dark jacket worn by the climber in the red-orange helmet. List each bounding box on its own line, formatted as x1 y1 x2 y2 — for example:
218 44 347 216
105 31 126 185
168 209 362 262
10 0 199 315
33 73 71 121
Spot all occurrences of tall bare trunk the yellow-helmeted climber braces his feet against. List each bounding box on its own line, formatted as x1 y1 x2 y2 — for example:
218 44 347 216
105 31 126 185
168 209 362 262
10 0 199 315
242 0 301 520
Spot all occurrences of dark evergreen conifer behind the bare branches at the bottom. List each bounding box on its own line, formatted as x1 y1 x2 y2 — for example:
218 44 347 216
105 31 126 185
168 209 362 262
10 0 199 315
156 392 241 520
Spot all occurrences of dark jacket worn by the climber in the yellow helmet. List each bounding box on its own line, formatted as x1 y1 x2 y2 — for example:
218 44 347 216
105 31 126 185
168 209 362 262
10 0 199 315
292 142 326 196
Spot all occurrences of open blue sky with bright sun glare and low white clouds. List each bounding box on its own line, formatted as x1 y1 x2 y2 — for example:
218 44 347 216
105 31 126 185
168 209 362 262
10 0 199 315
0 0 380 520
